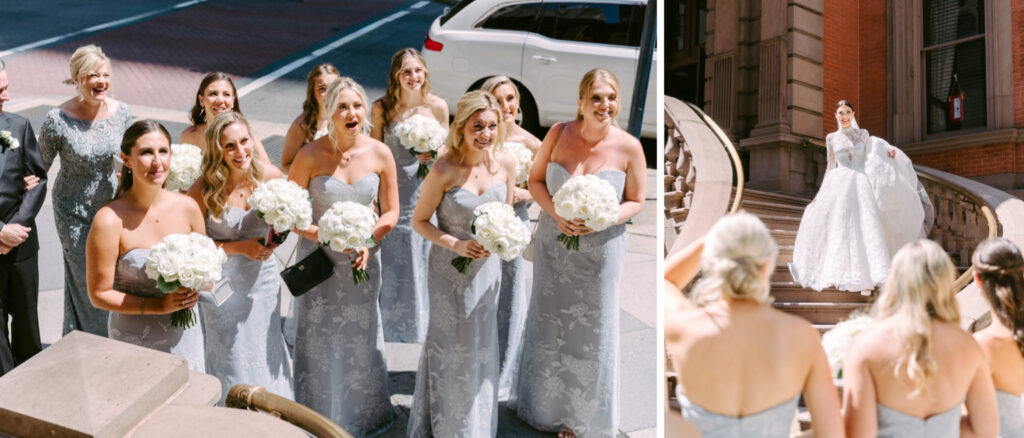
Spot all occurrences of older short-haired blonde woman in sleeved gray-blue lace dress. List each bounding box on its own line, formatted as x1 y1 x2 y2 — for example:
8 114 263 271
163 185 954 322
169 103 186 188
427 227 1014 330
39 45 131 337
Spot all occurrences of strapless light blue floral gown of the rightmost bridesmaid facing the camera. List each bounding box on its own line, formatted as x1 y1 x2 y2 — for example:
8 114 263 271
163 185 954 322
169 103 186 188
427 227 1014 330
515 163 626 437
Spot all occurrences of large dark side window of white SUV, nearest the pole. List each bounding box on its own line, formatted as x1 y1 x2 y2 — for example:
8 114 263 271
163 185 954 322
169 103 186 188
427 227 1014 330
537 2 644 47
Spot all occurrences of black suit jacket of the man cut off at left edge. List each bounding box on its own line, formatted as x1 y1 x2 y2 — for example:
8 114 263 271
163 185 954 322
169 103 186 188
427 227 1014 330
0 113 46 264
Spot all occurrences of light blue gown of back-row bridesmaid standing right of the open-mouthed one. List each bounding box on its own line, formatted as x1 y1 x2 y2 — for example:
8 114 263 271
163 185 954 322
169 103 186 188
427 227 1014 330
381 123 430 343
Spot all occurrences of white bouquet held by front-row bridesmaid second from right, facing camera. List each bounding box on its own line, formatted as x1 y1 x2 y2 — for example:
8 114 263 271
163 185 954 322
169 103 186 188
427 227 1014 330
452 202 529 274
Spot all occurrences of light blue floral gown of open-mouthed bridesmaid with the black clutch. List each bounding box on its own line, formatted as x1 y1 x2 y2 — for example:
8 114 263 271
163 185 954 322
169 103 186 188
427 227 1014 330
295 173 394 437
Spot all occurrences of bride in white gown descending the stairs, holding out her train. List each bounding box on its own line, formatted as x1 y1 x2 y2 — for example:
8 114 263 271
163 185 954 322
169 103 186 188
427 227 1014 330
790 100 931 294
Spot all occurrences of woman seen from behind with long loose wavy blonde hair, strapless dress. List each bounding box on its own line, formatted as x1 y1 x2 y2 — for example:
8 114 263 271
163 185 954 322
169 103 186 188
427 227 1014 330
843 240 999 438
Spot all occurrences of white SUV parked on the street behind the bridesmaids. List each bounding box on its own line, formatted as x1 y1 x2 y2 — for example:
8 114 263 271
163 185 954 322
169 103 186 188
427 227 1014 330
423 0 657 138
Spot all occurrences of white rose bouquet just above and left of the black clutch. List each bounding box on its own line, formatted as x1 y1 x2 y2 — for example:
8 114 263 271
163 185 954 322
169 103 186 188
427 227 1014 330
249 178 313 248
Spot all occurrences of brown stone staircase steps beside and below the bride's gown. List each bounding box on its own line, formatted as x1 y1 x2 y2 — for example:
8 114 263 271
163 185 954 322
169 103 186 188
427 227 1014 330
733 188 874 333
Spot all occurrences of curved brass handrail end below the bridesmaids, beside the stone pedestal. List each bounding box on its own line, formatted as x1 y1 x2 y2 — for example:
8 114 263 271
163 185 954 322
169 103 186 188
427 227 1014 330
224 384 352 438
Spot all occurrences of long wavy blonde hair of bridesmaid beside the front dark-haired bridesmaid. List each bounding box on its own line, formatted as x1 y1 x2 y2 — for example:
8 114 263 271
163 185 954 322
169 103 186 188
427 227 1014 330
200 112 263 216
